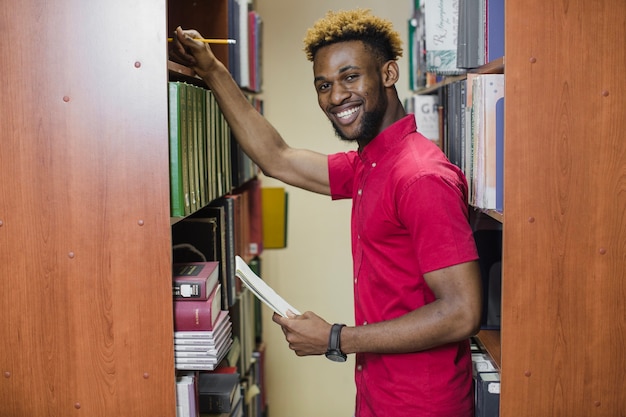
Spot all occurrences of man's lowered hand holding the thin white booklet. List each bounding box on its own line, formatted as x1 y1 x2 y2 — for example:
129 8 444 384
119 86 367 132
272 311 331 356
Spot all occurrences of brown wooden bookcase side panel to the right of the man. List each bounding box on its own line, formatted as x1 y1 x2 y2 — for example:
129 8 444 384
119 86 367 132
501 0 626 417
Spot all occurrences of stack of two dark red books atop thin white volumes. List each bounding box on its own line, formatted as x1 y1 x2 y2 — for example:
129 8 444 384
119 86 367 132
172 261 233 371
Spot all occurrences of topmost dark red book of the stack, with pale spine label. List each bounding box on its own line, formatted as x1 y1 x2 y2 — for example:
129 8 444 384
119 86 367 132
172 261 219 300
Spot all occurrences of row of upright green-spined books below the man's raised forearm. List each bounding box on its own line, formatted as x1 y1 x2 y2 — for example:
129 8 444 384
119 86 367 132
169 81 262 217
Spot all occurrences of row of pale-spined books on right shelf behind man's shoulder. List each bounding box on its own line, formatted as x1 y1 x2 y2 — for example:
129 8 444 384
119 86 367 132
406 73 504 212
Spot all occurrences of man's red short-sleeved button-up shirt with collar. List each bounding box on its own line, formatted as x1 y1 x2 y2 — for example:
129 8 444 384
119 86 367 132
328 115 478 417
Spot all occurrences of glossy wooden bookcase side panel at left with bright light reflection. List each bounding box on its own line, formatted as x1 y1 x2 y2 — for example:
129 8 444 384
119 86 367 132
0 0 175 417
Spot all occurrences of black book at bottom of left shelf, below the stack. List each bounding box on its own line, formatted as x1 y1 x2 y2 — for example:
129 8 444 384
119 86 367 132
198 372 241 413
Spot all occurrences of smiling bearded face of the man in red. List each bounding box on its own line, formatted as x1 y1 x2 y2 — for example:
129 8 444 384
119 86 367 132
313 41 387 147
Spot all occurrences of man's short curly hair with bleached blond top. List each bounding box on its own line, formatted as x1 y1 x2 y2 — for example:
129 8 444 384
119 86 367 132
304 9 402 62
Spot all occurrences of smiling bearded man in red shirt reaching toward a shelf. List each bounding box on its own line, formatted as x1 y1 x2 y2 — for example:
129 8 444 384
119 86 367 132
175 10 481 417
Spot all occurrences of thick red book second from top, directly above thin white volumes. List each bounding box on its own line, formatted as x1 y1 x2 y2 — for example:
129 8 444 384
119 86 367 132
174 284 222 331
